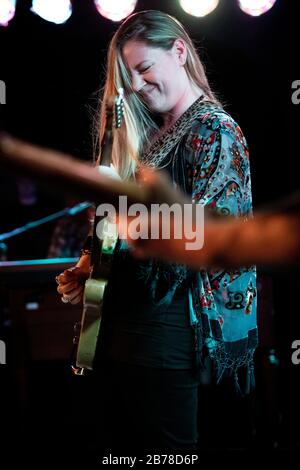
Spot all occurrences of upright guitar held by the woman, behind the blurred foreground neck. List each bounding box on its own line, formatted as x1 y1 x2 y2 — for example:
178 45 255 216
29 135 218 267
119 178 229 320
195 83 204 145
72 89 124 375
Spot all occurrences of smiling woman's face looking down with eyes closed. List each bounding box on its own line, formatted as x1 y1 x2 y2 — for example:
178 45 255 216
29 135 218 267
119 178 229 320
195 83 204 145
123 39 187 113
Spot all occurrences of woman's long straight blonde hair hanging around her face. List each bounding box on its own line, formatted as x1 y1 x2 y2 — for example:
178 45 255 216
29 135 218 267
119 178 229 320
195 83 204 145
98 10 218 179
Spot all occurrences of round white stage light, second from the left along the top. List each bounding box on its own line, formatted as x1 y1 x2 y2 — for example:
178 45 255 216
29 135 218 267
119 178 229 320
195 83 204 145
31 0 72 24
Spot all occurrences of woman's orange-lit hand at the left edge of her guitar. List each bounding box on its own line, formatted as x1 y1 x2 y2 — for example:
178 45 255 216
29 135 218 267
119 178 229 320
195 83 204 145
55 254 91 305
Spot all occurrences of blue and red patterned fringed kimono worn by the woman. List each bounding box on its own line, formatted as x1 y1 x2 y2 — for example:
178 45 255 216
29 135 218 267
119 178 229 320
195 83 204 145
142 98 257 393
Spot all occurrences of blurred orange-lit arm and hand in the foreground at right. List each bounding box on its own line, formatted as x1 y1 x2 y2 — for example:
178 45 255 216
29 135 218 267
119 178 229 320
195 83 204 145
127 169 300 268
